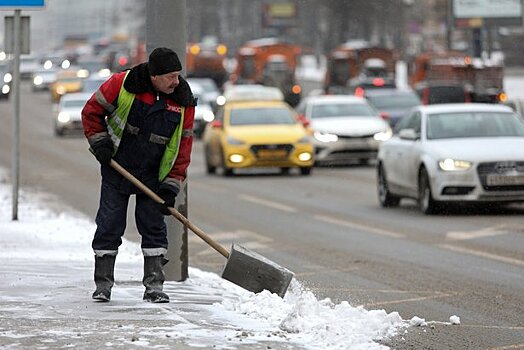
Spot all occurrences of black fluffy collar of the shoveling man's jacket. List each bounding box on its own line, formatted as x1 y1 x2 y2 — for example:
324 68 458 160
124 62 196 107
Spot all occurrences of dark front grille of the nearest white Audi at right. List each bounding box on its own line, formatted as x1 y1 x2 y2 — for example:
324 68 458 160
477 161 524 191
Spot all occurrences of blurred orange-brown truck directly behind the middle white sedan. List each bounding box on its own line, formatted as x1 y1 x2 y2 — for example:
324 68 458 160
324 41 398 93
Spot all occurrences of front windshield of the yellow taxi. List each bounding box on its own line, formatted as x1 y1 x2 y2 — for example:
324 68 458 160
229 107 296 125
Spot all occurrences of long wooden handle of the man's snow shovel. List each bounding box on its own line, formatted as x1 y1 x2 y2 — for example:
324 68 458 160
110 159 229 259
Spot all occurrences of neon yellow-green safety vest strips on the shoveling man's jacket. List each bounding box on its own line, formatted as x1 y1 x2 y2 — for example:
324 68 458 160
107 71 185 181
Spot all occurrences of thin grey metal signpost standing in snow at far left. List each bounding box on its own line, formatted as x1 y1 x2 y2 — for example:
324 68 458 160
11 10 22 221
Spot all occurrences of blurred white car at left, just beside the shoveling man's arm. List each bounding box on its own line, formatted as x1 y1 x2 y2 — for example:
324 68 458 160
55 92 92 136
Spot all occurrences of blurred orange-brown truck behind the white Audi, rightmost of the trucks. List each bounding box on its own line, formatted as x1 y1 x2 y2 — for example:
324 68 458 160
410 51 506 103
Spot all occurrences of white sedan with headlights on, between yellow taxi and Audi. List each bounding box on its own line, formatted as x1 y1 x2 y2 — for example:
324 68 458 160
296 95 392 165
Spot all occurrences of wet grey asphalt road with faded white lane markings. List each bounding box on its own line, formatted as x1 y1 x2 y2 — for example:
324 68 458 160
0 84 524 350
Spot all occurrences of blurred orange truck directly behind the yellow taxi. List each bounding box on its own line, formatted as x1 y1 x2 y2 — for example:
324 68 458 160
231 38 302 106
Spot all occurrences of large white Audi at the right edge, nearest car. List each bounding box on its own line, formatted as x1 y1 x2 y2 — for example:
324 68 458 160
377 103 524 214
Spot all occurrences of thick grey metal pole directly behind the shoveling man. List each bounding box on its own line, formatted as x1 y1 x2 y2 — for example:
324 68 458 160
146 0 188 281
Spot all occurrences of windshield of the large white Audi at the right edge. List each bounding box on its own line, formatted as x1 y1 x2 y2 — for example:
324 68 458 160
427 112 524 139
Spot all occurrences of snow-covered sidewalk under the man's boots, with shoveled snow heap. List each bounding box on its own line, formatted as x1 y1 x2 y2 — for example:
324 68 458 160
0 169 410 350
